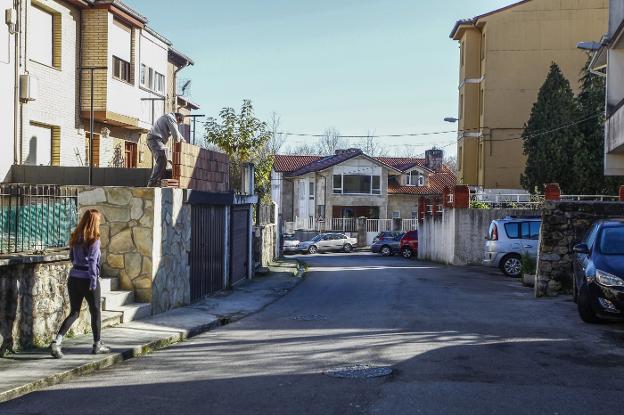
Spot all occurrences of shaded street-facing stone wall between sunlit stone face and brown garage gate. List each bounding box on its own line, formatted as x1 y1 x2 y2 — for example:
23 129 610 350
151 189 191 314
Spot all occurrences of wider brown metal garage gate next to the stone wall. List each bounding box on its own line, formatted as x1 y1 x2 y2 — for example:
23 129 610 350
189 205 225 301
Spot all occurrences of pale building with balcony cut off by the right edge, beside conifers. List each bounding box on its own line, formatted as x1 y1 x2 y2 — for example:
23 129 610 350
591 0 624 176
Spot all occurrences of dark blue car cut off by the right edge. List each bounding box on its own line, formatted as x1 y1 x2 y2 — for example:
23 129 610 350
572 219 624 323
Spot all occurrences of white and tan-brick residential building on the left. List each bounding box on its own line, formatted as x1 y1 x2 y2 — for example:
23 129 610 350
0 0 198 180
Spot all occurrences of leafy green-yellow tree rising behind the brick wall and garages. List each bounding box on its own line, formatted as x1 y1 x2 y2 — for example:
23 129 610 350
205 100 273 202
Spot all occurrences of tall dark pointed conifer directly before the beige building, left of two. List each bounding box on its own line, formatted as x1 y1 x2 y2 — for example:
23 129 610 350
520 62 583 193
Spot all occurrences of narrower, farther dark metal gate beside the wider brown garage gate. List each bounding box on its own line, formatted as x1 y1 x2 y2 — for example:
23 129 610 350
230 205 249 285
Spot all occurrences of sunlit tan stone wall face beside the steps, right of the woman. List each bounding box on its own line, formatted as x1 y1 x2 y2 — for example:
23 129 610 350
78 187 155 303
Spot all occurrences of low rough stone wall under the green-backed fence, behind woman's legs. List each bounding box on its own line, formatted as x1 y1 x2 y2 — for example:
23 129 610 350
0 252 91 356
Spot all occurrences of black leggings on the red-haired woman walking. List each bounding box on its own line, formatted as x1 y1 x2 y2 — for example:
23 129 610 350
59 277 102 342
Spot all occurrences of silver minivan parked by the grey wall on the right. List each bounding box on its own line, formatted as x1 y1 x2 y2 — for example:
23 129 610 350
483 216 542 277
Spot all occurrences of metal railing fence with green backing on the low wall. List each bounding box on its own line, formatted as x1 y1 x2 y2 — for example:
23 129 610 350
0 184 78 254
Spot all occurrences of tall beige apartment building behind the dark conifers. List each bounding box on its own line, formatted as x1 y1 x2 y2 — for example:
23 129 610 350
451 0 609 189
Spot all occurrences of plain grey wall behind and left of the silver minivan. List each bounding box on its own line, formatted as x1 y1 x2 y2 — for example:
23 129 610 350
418 209 535 265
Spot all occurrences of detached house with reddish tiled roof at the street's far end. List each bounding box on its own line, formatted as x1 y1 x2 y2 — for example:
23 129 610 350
272 149 456 228
